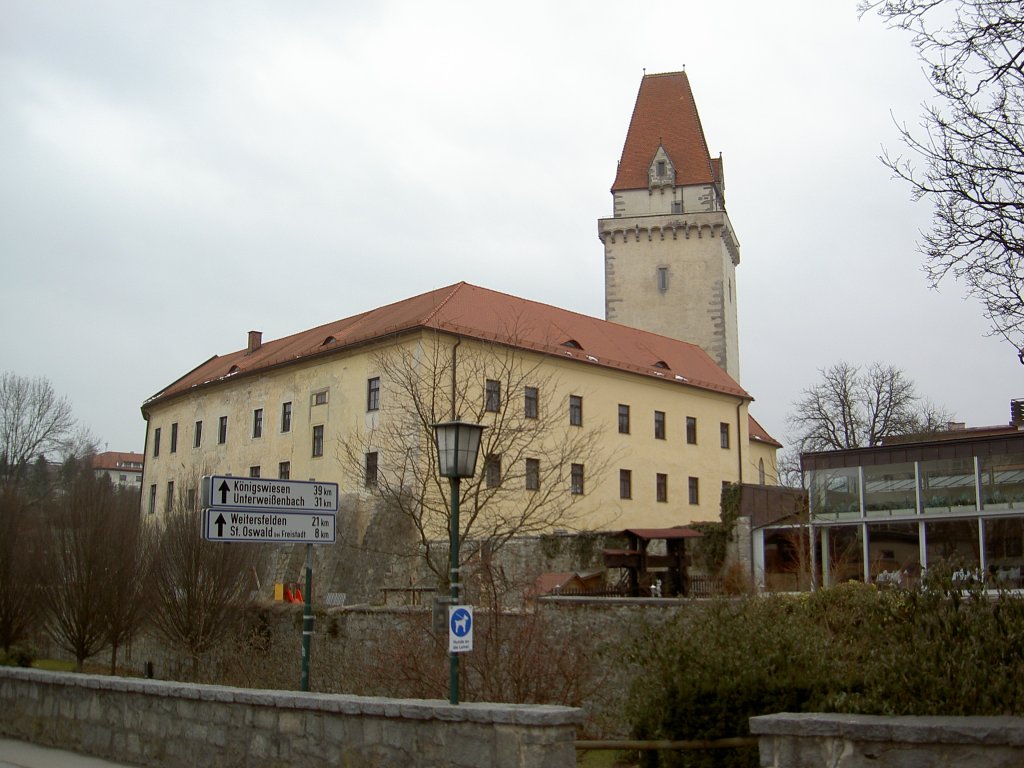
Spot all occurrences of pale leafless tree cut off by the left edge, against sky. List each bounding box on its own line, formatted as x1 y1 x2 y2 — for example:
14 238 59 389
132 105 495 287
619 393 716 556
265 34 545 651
0 372 77 485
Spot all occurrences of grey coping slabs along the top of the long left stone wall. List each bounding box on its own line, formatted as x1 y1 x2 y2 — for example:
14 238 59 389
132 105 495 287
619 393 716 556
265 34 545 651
0 667 583 726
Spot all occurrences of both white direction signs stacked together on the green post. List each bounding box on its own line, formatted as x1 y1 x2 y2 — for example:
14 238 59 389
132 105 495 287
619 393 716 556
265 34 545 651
203 475 338 544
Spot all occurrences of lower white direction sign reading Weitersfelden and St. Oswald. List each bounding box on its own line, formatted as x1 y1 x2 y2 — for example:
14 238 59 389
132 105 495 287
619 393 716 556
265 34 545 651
203 509 337 544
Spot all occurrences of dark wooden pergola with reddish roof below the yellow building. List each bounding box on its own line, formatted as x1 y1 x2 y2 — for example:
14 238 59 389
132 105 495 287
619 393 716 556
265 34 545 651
604 525 702 597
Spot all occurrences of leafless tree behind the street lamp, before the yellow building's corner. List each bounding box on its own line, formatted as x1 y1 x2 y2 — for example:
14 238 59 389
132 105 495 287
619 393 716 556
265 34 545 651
339 334 609 584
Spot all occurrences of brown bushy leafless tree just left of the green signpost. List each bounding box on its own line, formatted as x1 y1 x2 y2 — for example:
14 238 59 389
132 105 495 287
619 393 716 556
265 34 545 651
150 487 260 676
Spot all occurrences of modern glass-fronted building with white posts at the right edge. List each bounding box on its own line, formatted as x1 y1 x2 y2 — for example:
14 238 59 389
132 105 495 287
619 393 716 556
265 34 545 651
801 425 1024 588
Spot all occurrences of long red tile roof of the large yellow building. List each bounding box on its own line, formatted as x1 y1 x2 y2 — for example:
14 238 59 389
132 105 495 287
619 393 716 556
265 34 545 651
146 283 753 403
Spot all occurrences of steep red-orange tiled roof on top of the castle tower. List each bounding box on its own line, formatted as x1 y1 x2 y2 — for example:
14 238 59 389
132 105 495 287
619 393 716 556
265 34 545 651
611 72 722 191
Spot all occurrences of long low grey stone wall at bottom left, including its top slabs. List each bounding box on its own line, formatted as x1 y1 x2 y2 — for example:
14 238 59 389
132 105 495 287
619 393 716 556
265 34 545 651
0 668 581 768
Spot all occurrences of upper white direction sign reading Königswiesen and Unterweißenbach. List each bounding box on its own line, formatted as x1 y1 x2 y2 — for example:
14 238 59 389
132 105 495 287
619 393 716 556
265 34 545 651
203 475 338 512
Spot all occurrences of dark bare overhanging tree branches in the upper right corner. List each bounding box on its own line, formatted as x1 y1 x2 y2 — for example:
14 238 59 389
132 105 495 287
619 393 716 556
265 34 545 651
859 0 1024 354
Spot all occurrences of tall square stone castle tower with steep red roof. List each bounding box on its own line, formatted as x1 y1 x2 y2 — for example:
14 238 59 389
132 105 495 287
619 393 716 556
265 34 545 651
598 72 739 381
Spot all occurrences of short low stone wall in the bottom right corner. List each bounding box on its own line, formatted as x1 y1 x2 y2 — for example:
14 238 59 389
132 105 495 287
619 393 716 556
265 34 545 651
751 713 1024 768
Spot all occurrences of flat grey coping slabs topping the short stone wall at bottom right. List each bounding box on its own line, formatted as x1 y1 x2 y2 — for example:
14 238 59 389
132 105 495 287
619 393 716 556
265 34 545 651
750 712 1024 746
